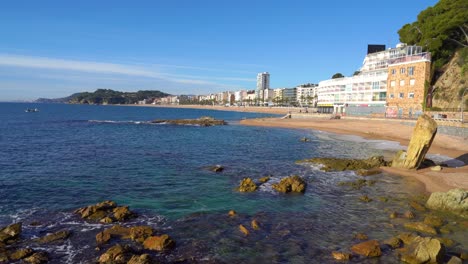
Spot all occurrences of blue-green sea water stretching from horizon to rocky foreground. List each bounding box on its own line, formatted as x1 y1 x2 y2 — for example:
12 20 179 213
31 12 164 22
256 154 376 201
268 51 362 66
0 103 468 263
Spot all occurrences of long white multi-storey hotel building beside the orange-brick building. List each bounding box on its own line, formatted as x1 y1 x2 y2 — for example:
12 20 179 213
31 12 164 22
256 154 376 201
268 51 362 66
317 44 422 115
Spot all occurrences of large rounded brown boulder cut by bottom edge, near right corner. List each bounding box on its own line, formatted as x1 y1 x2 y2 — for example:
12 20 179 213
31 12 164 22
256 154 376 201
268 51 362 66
402 236 445 263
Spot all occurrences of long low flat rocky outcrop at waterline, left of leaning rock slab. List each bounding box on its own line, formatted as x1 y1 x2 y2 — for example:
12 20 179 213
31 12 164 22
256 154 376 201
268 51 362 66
297 156 387 173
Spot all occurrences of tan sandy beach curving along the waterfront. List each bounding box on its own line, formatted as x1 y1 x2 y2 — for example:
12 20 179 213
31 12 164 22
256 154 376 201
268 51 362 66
140 105 468 192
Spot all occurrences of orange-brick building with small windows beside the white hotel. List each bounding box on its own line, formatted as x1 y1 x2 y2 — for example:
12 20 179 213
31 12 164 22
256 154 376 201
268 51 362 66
385 52 431 118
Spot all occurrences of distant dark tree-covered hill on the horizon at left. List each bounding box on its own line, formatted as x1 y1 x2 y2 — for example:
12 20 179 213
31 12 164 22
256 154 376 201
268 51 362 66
36 89 169 104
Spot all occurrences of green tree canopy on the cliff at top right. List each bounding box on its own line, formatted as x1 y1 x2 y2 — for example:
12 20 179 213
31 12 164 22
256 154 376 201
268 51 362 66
398 0 468 79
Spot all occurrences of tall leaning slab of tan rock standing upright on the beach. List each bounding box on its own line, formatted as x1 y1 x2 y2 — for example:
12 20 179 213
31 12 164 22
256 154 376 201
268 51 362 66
392 115 437 169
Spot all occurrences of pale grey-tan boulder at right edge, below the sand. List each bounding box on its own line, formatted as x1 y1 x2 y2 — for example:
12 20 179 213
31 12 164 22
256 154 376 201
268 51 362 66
426 188 468 218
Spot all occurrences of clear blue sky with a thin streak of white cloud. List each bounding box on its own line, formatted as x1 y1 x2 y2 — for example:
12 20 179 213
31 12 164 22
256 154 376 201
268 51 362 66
0 0 437 101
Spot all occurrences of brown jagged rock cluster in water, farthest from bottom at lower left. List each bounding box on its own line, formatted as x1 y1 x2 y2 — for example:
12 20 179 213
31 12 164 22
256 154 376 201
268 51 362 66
75 201 135 223
